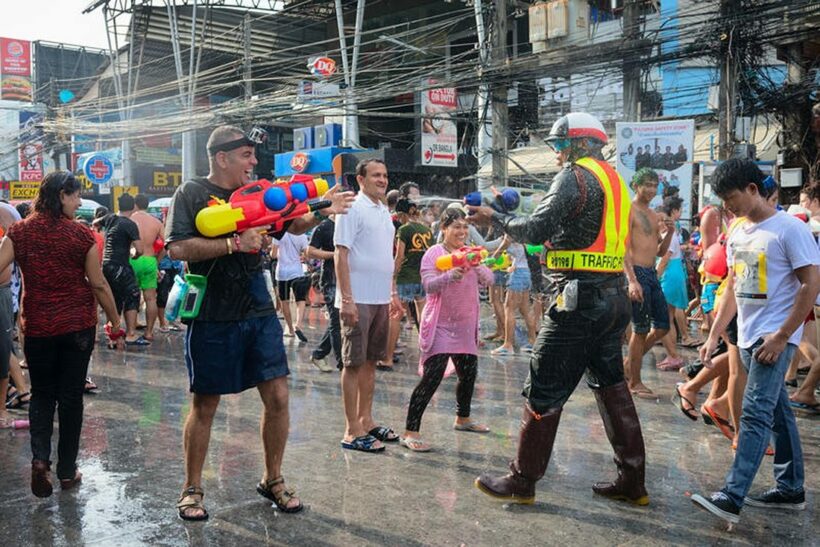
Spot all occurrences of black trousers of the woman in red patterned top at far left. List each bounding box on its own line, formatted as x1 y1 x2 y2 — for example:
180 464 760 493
25 327 97 479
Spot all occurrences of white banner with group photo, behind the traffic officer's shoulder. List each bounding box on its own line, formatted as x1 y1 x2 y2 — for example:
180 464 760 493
615 120 695 222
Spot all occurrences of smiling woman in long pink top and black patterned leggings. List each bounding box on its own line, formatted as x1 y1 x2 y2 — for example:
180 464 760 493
401 209 493 452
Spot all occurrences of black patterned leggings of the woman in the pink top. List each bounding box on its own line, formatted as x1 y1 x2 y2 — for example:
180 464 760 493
406 353 478 431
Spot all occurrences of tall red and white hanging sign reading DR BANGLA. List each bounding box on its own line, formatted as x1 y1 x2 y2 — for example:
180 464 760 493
419 79 458 167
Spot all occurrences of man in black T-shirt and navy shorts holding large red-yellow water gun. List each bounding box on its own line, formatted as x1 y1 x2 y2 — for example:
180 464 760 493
165 126 353 520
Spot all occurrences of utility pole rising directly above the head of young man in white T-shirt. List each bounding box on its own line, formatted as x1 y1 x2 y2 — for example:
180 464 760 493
718 0 739 160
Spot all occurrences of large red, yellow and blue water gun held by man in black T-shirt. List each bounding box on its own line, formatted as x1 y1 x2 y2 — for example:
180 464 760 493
196 175 332 237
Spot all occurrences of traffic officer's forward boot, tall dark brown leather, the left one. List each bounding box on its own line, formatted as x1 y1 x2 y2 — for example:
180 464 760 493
475 404 561 505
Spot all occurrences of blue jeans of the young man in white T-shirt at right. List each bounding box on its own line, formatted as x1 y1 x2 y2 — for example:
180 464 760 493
723 340 803 507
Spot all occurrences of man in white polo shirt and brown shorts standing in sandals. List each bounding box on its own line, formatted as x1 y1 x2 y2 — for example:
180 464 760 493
333 159 401 452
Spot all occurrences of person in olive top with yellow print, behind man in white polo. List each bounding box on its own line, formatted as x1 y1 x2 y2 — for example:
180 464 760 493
384 198 434 370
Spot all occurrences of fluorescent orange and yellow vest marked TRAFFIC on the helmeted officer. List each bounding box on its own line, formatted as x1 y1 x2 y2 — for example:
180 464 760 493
546 158 632 273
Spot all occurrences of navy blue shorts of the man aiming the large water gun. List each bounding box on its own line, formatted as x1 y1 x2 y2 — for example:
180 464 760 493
185 315 290 395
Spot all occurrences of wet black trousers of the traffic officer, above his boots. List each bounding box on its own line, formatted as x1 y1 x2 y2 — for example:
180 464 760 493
523 282 632 414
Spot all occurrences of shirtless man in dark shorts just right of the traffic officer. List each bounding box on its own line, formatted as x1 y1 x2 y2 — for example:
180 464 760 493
624 167 675 399
